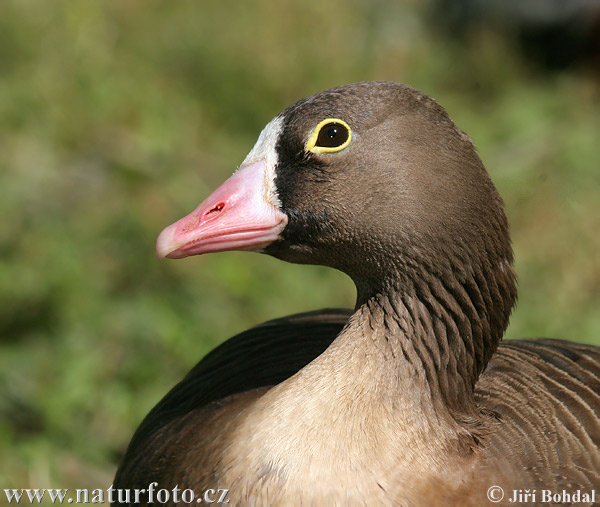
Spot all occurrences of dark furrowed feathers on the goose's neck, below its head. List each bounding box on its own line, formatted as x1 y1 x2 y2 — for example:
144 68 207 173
352 250 516 432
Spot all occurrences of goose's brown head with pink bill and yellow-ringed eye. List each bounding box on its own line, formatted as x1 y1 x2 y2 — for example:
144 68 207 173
156 82 516 378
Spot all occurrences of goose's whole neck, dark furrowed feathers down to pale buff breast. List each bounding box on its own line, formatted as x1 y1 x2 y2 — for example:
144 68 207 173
220 263 514 487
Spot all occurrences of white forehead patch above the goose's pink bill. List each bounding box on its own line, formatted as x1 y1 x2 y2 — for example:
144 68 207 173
242 116 283 208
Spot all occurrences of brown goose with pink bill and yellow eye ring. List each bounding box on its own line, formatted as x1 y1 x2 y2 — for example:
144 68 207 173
113 82 600 506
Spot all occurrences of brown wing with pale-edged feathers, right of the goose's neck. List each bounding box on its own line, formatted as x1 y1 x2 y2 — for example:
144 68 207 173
476 339 600 490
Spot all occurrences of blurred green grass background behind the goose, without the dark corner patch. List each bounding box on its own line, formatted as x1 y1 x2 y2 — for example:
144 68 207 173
0 0 600 489
